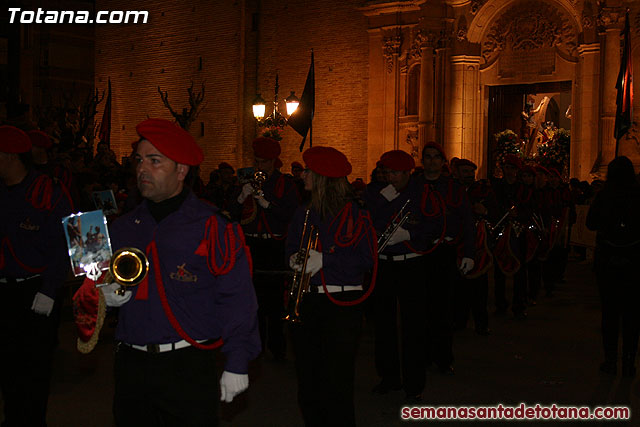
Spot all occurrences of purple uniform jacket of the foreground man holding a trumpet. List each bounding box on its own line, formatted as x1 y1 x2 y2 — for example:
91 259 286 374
110 192 260 374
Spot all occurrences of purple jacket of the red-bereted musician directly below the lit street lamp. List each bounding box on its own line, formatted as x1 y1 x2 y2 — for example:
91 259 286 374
229 170 300 235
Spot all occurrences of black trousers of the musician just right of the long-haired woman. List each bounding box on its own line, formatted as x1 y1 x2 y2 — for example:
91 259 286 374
372 257 427 395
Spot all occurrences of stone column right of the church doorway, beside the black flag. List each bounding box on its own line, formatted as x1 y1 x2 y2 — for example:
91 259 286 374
600 8 624 168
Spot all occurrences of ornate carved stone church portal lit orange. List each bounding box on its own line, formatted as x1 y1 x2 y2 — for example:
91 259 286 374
361 0 640 179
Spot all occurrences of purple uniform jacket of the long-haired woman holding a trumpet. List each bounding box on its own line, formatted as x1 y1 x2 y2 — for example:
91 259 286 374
285 202 377 286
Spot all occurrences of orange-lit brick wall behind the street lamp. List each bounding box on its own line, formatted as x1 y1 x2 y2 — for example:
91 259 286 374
95 0 368 181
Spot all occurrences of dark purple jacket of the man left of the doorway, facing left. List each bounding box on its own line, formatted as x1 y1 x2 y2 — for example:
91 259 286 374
417 175 476 258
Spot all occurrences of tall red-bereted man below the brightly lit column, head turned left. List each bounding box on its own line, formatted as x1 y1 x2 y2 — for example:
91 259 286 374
420 142 476 375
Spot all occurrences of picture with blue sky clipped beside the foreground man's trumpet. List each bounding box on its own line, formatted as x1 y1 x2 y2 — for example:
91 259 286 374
62 211 112 276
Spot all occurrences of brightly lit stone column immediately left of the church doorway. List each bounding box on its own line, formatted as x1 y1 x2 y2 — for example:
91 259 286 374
444 55 483 166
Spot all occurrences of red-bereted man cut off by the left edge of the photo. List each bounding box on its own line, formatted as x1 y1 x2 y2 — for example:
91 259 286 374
0 126 71 426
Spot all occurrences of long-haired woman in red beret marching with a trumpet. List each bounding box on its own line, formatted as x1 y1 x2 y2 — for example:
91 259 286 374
286 147 376 426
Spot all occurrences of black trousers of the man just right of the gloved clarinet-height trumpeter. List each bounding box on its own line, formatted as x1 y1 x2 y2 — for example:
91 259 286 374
422 243 460 367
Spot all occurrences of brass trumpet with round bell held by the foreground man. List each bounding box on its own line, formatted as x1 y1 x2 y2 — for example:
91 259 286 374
103 248 149 295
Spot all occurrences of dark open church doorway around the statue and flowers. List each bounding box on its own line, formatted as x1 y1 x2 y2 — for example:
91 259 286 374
487 81 571 176
